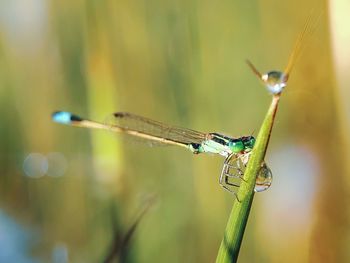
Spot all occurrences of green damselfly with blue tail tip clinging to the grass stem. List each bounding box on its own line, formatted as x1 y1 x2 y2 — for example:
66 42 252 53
52 111 272 200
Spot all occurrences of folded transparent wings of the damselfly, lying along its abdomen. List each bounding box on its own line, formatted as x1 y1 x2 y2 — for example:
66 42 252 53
106 112 208 145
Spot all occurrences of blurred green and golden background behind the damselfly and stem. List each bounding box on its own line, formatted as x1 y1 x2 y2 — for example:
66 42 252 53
0 0 350 263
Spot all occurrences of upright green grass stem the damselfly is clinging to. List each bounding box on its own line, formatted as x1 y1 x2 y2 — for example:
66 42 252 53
216 95 280 263
